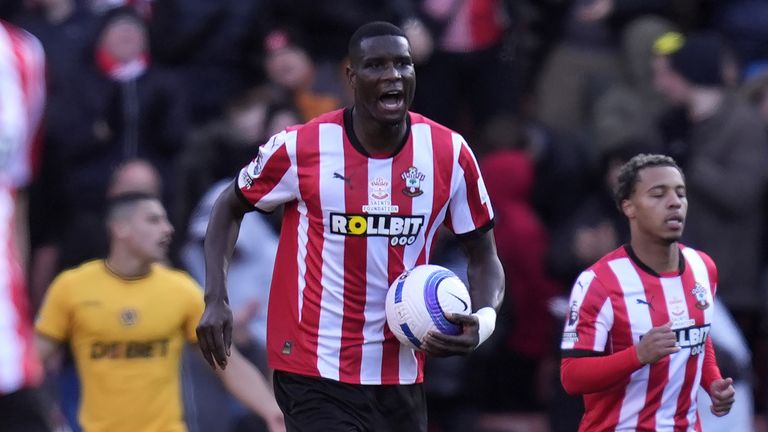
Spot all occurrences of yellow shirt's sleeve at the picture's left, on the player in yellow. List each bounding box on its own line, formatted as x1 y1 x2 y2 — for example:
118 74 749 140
35 275 72 342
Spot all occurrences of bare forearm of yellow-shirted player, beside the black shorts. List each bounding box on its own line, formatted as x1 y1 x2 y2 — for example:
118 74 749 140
216 347 285 432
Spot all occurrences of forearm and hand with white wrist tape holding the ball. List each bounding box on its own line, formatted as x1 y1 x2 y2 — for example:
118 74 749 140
422 229 504 356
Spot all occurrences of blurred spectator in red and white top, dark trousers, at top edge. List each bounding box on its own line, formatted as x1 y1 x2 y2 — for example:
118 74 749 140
415 0 520 144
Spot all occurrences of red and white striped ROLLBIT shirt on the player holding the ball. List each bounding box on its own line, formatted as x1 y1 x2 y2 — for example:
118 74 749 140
237 110 493 384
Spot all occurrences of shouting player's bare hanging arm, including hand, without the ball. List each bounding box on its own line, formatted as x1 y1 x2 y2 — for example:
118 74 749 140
197 184 253 369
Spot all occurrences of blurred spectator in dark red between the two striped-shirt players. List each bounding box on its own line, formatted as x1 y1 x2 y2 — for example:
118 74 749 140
479 127 558 411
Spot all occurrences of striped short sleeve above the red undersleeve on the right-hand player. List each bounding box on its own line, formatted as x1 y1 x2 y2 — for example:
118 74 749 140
560 270 613 357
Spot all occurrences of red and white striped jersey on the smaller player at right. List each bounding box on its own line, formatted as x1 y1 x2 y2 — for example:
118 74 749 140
561 246 717 432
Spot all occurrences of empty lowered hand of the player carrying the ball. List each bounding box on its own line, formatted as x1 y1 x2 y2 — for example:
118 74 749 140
196 301 232 369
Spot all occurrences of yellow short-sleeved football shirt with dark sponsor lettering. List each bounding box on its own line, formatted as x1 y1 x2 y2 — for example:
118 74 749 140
35 260 204 432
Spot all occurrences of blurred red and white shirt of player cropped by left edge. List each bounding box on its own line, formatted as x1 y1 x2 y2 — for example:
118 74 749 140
0 21 45 394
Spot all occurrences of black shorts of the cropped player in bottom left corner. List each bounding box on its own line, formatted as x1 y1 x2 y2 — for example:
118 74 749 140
0 389 52 432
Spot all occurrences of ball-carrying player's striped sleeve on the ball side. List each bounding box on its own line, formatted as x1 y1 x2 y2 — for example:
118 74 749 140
446 135 493 235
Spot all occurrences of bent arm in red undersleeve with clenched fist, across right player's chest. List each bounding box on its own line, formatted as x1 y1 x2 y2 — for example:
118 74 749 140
560 322 680 395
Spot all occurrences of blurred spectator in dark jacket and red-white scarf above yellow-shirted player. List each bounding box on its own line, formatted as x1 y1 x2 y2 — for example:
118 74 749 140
33 8 186 286
